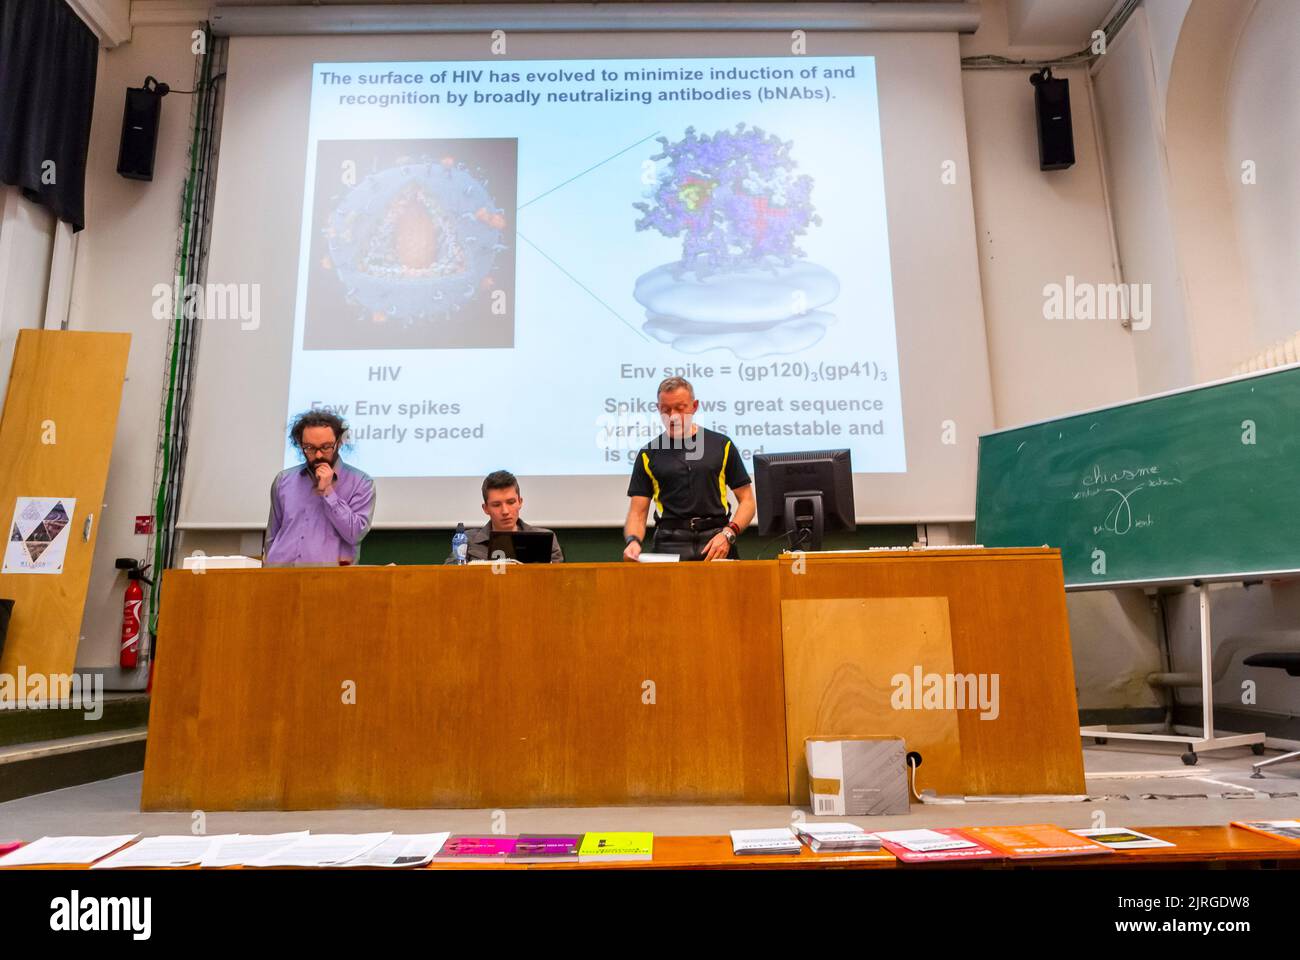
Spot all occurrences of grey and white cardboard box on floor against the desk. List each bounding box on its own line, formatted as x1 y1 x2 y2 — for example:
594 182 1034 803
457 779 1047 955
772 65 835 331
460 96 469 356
803 736 909 817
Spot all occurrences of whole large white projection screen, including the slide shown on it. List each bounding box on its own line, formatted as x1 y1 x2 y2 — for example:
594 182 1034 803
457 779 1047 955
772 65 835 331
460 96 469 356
181 33 993 528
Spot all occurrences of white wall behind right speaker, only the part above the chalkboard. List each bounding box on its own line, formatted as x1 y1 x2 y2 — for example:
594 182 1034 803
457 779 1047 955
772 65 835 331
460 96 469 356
963 70 1138 427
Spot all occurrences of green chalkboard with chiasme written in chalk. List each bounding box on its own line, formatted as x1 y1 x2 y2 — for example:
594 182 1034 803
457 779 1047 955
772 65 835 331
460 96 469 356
975 367 1300 587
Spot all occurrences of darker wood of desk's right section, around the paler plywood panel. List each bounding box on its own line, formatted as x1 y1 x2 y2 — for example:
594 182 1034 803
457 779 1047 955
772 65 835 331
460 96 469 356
780 549 1084 803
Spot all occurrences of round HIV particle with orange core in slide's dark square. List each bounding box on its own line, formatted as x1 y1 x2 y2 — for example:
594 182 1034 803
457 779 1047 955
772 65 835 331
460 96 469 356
324 156 506 325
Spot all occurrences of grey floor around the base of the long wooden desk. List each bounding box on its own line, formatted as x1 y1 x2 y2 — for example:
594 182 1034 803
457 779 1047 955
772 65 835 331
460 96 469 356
0 740 1300 840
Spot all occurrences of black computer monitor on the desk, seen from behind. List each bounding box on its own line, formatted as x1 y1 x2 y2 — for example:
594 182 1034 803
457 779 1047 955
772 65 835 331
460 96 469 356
754 450 857 550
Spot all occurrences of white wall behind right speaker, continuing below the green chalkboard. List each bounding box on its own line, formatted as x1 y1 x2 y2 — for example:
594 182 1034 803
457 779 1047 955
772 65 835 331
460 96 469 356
962 0 1164 710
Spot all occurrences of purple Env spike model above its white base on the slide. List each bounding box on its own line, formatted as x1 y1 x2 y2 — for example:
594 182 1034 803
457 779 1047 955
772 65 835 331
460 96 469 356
633 124 822 277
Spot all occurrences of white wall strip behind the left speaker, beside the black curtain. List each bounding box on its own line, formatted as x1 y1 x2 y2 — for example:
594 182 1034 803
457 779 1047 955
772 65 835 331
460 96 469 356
69 18 204 682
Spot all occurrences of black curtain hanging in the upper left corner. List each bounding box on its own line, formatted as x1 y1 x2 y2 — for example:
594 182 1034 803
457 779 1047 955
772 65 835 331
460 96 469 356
0 0 99 230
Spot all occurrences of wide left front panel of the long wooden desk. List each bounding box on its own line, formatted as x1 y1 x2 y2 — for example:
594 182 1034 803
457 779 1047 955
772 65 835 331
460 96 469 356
142 562 787 810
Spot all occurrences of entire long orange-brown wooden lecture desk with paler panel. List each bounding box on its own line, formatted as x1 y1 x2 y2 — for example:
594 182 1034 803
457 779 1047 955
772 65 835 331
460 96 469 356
142 549 1083 810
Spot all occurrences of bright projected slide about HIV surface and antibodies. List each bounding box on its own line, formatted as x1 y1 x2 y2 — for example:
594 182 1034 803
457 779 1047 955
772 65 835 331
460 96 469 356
283 56 907 477
